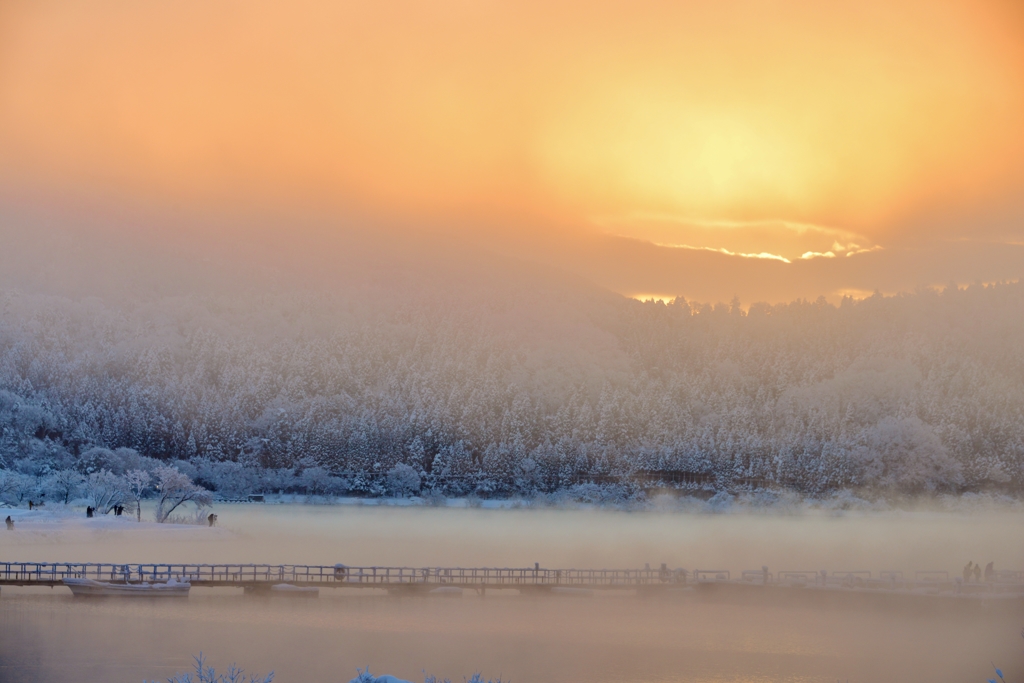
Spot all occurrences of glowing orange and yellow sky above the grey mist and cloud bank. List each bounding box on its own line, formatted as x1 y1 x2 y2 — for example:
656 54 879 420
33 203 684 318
0 0 1024 296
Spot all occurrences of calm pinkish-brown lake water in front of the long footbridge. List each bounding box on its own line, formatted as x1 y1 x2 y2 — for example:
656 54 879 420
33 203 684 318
0 590 1021 683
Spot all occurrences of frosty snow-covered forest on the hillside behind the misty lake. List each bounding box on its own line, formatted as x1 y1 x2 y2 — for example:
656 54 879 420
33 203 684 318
0 268 1024 498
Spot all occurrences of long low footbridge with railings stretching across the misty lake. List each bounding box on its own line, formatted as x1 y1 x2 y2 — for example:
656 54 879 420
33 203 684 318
0 562 1024 599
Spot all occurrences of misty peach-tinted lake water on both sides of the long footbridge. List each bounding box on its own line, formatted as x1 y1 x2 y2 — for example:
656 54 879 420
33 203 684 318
0 506 1024 683
